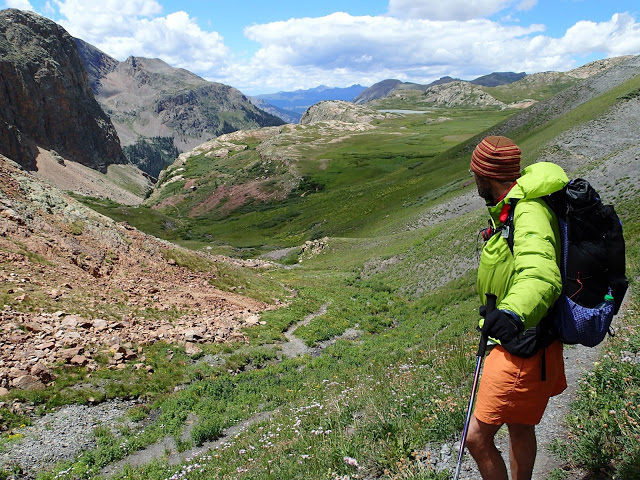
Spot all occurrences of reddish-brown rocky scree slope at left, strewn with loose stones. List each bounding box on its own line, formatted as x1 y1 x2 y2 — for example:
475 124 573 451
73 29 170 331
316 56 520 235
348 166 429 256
0 156 271 395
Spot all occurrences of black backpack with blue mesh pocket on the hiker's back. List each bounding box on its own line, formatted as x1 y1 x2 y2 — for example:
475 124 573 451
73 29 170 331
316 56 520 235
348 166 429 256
507 178 629 347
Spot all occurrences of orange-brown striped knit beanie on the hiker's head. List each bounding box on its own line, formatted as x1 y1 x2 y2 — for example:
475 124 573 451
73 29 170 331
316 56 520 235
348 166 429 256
471 136 521 181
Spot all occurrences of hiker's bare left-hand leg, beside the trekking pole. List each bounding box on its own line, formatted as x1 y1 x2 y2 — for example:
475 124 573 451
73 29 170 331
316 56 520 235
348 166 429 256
467 415 509 480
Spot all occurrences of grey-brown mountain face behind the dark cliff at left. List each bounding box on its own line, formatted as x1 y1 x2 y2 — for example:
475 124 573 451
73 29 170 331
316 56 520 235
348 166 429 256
76 40 284 175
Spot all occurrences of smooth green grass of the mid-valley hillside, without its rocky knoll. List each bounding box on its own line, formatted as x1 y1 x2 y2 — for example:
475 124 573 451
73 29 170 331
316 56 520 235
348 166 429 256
81 110 512 254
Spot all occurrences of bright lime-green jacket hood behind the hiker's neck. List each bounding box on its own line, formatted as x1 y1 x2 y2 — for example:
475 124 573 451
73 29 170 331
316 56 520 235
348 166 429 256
506 162 569 199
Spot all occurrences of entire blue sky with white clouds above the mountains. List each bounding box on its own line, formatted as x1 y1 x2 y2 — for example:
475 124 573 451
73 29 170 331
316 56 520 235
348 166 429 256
0 0 640 95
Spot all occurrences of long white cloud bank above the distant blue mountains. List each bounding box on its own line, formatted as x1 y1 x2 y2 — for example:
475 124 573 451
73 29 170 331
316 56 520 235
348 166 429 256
245 13 543 77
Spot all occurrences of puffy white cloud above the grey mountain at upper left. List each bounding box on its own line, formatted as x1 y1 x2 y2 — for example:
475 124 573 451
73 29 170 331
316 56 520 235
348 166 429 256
55 0 229 72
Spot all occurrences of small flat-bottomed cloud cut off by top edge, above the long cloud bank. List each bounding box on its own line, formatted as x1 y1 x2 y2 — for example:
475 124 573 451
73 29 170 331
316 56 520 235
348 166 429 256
389 0 516 20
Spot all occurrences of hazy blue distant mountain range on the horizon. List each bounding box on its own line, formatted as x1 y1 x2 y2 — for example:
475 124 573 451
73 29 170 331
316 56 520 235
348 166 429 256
253 85 367 123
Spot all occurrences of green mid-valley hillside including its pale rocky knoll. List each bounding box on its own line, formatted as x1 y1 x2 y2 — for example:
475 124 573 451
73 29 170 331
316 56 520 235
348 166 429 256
85 110 511 254
